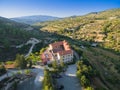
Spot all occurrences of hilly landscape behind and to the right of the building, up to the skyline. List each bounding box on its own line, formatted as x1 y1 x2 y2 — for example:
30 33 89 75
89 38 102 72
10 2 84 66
0 8 120 90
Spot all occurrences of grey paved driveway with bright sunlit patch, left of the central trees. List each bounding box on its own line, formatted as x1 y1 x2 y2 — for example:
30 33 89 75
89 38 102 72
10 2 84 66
17 66 44 90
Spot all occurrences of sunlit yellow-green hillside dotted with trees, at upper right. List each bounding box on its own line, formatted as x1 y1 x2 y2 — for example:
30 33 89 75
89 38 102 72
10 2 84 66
36 8 120 52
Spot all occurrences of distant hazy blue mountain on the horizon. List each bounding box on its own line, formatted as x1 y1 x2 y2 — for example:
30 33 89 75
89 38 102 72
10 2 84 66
11 15 59 24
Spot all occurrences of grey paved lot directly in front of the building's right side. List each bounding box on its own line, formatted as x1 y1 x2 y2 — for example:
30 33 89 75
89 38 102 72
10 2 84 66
57 65 82 90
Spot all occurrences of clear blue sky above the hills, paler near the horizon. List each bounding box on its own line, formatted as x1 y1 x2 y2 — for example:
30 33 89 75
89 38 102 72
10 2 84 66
0 0 120 18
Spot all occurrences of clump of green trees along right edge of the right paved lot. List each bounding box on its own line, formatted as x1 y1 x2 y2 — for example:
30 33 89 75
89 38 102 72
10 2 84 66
76 60 96 88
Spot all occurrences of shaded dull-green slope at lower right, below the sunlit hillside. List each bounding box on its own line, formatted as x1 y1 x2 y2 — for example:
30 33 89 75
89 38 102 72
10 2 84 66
83 47 120 90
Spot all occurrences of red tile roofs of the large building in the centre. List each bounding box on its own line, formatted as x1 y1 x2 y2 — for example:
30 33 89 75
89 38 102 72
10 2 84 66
41 40 73 63
